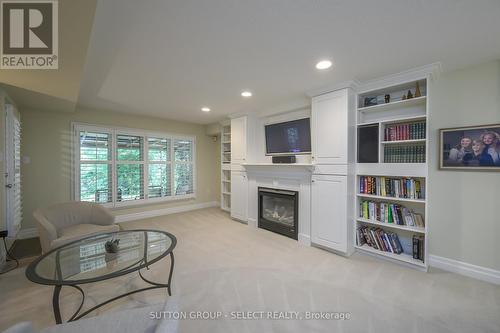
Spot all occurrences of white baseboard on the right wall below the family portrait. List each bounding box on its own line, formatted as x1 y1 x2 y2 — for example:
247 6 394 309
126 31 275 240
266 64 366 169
429 255 500 285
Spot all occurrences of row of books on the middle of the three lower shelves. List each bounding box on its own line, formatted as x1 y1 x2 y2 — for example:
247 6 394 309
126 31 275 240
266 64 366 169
359 200 425 228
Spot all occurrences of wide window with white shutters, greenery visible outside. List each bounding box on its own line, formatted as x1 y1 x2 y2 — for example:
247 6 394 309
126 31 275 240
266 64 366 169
74 125 195 206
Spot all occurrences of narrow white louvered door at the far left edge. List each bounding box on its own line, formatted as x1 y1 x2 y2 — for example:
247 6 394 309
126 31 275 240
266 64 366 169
4 104 22 237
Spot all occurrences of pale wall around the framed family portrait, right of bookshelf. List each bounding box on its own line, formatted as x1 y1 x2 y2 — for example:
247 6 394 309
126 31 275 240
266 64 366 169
428 61 500 270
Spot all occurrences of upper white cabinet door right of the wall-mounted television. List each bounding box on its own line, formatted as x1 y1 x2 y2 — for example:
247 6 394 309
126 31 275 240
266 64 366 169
311 89 349 164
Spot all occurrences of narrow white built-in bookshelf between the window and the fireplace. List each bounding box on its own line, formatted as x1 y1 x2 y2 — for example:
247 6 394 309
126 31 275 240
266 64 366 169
220 124 231 212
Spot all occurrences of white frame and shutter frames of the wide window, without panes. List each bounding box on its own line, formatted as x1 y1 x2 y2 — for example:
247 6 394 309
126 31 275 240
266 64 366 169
71 122 197 208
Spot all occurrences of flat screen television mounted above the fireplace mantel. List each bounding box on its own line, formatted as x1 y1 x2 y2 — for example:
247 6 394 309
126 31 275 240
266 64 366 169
265 118 311 155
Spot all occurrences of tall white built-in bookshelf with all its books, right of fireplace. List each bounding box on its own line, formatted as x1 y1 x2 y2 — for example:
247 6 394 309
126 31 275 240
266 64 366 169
354 75 430 270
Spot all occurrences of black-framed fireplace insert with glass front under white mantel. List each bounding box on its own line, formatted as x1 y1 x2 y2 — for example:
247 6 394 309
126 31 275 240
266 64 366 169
258 187 299 239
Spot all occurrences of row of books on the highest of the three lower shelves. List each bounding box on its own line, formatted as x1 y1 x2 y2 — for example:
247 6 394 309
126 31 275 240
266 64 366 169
359 176 425 199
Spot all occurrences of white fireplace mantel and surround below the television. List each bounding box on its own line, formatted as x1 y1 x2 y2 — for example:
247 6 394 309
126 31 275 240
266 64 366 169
243 163 314 245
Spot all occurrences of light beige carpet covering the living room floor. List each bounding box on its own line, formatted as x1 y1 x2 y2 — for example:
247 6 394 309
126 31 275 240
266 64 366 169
0 208 500 333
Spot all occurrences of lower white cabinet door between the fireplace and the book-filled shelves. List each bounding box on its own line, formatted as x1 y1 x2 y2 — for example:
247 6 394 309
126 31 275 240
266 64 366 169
311 175 348 253
